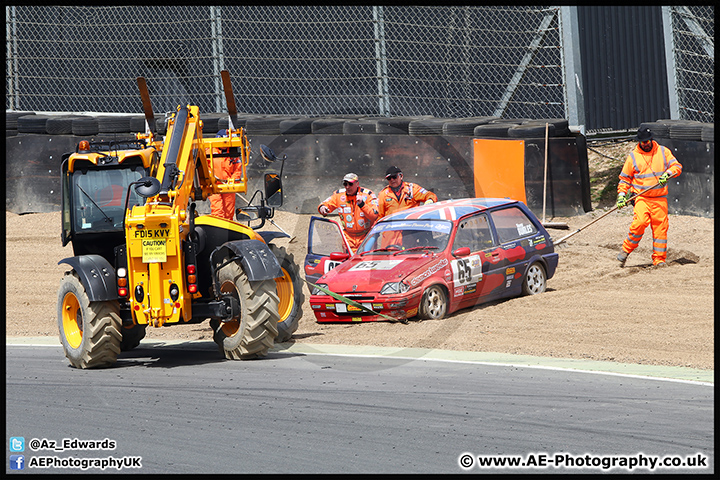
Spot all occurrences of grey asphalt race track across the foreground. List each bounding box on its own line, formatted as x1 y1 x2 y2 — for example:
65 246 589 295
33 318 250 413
6 339 714 474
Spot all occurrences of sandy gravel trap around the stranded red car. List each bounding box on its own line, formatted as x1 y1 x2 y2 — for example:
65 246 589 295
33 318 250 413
5 144 715 370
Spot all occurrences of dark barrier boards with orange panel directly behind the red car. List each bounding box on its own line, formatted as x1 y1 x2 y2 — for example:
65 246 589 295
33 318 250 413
242 129 591 216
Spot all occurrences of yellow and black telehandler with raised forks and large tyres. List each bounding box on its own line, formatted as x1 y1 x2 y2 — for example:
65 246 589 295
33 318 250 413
58 70 305 368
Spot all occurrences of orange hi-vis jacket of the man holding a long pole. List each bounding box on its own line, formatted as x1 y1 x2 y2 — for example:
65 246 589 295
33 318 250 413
618 141 682 199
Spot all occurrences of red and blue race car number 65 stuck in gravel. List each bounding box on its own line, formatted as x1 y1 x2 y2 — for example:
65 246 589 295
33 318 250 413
305 198 558 322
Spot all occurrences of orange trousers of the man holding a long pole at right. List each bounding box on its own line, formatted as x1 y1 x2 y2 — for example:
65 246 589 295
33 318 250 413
623 197 669 265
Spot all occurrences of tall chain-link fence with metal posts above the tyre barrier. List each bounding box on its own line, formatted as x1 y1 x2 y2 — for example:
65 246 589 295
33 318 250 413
5 5 714 122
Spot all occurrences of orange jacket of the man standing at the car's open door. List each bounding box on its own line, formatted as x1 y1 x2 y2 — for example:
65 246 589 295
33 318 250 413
318 187 378 253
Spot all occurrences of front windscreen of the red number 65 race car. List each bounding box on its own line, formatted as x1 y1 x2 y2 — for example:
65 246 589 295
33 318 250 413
357 219 453 254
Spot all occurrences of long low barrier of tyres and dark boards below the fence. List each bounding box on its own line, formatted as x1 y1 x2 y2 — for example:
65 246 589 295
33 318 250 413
6 112 714 218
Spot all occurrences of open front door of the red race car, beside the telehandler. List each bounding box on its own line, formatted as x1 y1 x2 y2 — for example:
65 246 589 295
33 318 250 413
305 216 352 283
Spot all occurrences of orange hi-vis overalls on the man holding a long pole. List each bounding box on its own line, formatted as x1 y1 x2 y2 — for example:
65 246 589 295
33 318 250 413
618 140 682 265
